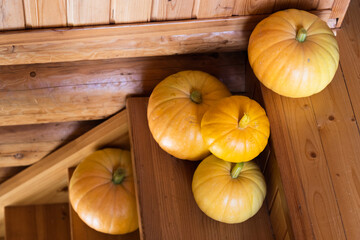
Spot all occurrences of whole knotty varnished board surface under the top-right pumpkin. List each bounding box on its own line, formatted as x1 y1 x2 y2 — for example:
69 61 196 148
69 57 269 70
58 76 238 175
262 0 360 239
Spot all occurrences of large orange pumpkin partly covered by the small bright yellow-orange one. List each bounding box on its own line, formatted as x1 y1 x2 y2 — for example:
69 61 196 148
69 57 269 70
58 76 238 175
147 71 231 160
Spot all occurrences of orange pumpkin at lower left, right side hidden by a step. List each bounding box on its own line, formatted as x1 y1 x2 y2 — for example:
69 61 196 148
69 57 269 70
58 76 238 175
69 148 138 234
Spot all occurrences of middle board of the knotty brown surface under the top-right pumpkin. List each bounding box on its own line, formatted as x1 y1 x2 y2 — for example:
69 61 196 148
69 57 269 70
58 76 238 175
311 69 360 239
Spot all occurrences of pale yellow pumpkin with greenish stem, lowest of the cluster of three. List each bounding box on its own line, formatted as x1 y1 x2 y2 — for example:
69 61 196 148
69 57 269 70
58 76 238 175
192 155 266 223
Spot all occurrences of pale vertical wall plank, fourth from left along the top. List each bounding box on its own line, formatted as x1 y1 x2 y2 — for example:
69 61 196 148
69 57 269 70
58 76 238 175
110 0 152 23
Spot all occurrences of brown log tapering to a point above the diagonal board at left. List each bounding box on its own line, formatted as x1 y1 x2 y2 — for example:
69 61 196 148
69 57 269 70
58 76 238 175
0 121 101 166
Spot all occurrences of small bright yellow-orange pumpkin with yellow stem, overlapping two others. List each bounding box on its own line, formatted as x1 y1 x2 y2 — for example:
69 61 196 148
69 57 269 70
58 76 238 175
201 96 270 162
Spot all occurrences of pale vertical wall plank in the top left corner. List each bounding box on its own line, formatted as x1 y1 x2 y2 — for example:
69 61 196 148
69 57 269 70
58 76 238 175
0 0 25 31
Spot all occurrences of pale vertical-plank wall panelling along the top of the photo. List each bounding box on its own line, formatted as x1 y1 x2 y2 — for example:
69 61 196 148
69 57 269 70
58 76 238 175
0 0 336 30
